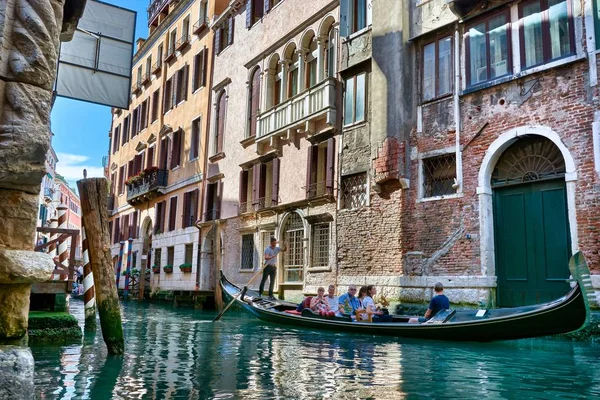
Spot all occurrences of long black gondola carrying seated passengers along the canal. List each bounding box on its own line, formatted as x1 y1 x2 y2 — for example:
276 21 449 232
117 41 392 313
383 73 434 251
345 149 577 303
220 253 594 342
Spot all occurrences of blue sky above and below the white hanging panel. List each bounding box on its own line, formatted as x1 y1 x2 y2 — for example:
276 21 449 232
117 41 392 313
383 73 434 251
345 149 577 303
51 0 148 187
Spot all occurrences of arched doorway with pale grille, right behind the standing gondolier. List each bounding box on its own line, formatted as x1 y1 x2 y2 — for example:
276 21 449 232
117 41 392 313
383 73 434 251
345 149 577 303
280 212 305 284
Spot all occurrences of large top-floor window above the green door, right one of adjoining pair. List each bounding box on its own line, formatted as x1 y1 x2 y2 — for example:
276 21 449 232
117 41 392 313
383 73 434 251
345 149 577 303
519 0 574 69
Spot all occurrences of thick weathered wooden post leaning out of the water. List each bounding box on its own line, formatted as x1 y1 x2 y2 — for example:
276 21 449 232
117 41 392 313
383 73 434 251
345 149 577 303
77 178 125 354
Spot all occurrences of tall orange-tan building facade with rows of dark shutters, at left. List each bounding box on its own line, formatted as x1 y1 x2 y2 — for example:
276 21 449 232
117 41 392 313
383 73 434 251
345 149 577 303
108 0 214 290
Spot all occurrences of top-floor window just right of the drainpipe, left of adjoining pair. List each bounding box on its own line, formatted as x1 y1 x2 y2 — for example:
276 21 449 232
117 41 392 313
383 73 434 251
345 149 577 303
466 11 512 86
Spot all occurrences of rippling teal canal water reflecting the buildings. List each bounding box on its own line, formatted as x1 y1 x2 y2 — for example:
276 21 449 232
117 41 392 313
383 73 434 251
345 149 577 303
32 300 600 400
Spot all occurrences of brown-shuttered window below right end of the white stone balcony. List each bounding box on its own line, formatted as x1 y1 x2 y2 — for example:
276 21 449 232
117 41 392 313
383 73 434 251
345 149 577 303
305 138 335 199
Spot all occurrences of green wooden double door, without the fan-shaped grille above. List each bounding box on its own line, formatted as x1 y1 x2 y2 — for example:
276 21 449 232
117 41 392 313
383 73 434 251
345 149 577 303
494 180 571 307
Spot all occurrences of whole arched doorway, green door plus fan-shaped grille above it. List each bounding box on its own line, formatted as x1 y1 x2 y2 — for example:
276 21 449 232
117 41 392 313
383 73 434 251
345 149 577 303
491 135 571 307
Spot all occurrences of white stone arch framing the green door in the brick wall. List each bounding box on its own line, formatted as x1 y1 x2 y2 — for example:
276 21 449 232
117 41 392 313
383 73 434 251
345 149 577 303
477 125 579 276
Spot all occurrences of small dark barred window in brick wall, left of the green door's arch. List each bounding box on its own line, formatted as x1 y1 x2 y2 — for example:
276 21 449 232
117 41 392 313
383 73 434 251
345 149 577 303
423 154 456 197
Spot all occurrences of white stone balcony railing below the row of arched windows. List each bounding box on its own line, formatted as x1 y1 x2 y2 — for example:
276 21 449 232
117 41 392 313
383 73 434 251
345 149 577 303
257 78 336 139
